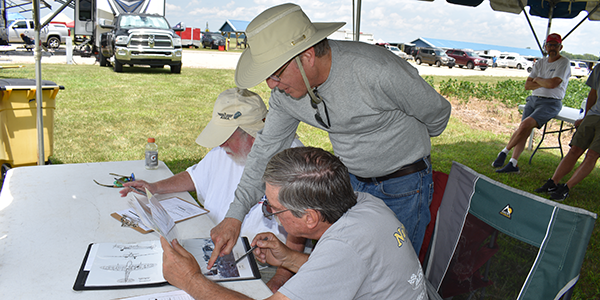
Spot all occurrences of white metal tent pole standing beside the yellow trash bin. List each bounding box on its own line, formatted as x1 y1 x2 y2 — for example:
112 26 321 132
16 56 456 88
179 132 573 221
32 0 45 166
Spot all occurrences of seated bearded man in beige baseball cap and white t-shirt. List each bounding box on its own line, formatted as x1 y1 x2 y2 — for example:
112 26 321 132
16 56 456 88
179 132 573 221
120 88 302 241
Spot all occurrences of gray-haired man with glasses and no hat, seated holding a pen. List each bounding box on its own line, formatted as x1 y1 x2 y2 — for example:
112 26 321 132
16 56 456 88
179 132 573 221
161 147 429 300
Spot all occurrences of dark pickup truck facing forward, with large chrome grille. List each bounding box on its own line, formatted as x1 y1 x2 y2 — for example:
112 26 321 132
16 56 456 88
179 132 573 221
99 13 184 74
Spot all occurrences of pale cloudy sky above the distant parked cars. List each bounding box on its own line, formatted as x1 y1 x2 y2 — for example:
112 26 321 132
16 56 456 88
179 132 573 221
41 0 600 56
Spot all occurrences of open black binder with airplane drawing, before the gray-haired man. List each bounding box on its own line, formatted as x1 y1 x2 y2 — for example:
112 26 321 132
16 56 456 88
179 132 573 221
73 237 260 291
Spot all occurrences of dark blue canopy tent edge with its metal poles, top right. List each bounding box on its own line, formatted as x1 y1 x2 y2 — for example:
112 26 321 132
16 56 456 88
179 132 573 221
352 0 600 54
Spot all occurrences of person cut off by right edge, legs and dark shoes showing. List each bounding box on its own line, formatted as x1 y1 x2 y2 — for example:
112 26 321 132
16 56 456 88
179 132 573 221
535 66 600 201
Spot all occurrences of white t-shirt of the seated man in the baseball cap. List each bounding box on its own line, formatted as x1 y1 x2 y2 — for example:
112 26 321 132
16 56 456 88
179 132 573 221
186 139 303 243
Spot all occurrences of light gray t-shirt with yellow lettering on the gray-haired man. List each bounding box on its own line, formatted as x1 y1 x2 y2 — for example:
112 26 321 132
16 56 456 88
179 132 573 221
279 193 428 300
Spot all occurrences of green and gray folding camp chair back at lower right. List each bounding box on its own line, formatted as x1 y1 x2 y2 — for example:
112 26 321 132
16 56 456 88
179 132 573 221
426 162 597 300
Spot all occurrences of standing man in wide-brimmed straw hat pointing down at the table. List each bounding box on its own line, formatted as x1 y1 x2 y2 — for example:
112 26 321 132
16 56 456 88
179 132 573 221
209 3 451 288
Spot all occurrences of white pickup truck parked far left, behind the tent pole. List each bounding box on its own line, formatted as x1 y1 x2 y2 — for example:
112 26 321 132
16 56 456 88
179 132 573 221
0 20 70 49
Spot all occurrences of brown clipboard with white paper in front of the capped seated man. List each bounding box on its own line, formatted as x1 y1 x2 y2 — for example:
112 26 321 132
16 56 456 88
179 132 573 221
110 197 209 234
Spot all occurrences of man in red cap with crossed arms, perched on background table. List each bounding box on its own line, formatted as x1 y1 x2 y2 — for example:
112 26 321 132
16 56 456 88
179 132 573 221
492 33 571 173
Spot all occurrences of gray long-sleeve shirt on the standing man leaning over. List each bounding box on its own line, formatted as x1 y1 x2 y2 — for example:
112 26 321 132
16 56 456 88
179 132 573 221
226 40 451 220
